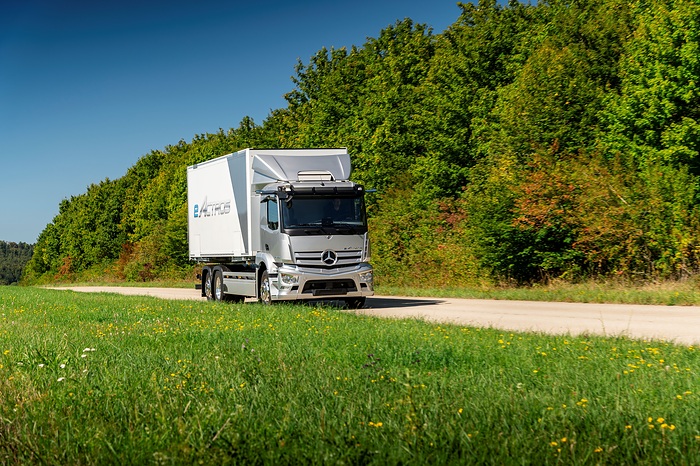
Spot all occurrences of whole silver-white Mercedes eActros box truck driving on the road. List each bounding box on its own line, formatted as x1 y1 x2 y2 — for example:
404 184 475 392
187 148 374 308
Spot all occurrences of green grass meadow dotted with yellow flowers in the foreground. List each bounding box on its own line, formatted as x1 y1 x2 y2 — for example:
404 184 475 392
0 287 700 465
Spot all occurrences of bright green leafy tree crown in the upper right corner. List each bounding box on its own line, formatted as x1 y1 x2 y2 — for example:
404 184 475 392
606 0 700 174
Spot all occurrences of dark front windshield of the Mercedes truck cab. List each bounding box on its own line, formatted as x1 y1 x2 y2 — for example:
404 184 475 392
282 196 367 233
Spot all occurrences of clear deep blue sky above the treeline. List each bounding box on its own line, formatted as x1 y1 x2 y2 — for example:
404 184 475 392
0 0 468 243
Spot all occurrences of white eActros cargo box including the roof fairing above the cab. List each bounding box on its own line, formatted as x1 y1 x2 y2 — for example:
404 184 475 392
187 148 351 261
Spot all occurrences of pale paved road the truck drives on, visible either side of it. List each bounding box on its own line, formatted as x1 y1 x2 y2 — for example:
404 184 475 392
52 287 700 345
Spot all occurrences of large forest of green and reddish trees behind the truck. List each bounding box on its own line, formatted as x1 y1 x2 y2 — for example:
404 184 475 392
24 0 700 287
